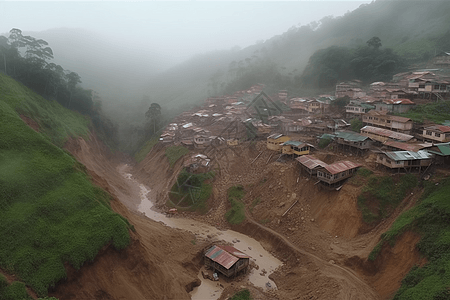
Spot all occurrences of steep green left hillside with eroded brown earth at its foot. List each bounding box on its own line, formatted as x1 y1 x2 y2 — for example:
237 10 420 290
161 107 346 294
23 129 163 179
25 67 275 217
0 75 198 299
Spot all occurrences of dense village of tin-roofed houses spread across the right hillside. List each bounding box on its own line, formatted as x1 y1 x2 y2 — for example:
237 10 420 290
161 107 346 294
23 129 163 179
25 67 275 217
160 67 450 188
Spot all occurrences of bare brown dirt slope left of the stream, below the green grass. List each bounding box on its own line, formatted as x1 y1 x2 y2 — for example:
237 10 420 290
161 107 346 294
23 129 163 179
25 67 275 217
50 136 202 299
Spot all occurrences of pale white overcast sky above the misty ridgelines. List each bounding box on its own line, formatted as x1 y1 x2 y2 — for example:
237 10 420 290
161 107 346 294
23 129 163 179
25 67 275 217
0 0 370 63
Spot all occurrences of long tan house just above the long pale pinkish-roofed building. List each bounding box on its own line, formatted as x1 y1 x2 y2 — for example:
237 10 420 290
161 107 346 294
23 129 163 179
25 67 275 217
362 110 413 134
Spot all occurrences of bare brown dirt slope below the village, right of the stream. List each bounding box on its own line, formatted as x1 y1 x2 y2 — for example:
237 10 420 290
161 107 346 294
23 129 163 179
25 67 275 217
136 142 426 299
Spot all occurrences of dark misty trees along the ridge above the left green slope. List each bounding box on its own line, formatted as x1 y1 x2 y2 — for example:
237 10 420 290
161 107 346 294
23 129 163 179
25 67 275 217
0 28 118 147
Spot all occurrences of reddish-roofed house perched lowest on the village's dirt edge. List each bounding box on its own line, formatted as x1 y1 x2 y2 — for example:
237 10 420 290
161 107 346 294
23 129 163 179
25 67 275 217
317 160 361 188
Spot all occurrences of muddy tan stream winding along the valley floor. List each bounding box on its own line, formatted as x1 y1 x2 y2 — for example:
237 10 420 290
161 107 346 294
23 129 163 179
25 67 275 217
121 172 282 300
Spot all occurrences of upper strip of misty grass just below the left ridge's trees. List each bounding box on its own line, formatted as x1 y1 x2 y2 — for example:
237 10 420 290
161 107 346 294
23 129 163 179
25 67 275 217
0 74 90 147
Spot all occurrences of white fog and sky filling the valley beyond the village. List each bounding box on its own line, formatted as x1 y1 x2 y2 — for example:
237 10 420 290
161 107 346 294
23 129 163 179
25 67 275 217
0 0 370 150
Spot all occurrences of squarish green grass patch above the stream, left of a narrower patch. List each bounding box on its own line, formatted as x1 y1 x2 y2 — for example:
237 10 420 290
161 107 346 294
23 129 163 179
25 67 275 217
168 169 215 213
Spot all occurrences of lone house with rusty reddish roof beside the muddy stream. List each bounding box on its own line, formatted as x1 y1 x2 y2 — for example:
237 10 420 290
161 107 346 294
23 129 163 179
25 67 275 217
204 245 250 277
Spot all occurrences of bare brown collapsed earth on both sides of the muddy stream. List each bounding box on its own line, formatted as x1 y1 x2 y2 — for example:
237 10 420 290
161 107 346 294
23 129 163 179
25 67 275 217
52 130 432 299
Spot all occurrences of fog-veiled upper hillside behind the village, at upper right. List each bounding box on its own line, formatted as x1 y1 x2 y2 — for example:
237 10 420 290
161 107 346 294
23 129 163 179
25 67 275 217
141 0 450 110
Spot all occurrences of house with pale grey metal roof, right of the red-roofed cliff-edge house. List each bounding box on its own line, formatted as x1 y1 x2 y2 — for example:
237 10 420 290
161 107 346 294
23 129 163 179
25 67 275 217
377 150 433 171
